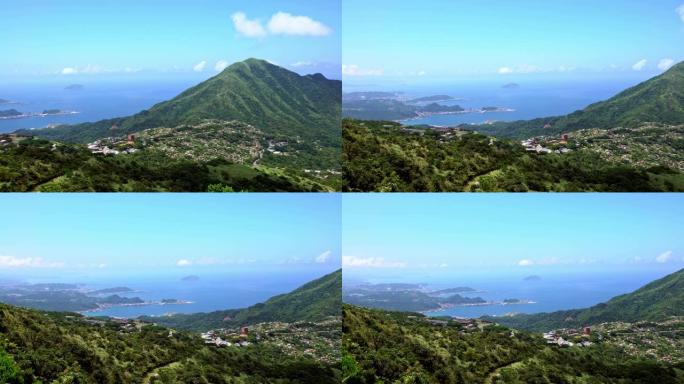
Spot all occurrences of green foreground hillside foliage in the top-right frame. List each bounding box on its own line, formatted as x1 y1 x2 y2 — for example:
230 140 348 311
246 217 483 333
342 119 684 192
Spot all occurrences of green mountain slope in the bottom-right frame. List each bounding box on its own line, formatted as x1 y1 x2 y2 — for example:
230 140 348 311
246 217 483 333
489 269 684 331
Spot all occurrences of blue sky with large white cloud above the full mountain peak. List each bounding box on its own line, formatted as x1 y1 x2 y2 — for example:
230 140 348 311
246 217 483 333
0 0 341 79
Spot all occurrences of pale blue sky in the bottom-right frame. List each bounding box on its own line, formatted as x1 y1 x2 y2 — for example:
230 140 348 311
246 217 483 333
342 193 684 282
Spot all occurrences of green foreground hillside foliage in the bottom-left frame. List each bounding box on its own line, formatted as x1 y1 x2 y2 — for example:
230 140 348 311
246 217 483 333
0 304 340 384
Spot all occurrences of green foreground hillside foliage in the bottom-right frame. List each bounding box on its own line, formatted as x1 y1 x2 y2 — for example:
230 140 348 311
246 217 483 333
342 305 684 384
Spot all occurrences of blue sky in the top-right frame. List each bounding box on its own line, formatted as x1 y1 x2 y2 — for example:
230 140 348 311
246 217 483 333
342 0 684 84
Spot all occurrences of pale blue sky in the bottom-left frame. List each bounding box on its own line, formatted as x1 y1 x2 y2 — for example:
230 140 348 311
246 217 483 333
0 194 341 277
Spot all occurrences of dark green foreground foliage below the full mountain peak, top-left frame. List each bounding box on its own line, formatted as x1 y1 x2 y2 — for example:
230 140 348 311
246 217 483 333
0 139 330 192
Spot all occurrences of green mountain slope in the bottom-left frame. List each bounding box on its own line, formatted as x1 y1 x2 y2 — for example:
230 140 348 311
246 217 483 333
149 270 342 331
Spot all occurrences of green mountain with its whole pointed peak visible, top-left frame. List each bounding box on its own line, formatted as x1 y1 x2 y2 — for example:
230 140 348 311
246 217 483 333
26 59 342 146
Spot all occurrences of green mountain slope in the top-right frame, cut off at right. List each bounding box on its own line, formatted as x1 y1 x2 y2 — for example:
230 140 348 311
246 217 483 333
476 62 684 138
